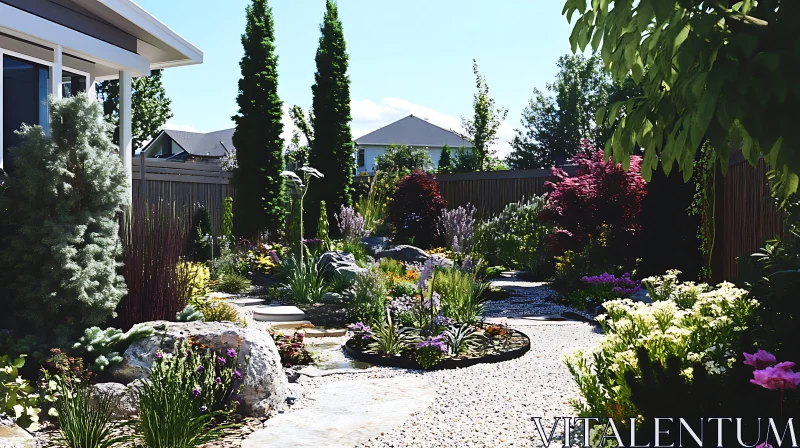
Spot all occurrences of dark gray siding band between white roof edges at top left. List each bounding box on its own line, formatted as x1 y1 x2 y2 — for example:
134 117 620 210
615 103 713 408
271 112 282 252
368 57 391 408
0 0 138 53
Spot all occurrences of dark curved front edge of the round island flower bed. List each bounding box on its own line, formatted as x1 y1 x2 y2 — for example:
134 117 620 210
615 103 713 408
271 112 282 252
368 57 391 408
344 329 531 370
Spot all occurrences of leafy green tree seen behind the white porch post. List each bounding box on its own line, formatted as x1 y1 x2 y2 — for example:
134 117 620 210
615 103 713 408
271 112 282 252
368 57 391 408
97 70 172 150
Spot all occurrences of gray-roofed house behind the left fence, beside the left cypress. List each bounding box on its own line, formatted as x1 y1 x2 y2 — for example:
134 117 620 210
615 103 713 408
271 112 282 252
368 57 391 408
142 128 235 162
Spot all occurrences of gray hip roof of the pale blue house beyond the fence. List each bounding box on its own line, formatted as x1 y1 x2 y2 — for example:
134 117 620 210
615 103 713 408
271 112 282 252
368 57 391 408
356 115 472 148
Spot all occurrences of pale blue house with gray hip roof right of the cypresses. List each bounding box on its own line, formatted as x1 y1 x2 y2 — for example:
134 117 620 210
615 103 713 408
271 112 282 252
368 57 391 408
355 115 472 174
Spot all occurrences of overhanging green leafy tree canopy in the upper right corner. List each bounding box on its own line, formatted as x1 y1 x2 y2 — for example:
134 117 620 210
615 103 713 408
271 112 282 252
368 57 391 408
563 0 800 197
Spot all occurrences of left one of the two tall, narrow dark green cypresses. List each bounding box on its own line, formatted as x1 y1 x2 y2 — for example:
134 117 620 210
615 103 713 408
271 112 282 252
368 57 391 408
231 0 286 238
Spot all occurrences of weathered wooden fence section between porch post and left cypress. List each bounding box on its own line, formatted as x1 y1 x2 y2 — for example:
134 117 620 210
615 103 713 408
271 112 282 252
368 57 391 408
133 157 233 235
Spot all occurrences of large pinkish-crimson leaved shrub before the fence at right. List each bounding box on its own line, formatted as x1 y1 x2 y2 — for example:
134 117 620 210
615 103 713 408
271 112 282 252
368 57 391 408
542 140 646 255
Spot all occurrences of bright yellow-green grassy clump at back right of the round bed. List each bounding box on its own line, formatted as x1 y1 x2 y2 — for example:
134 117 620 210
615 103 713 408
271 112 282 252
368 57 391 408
433 268 488 324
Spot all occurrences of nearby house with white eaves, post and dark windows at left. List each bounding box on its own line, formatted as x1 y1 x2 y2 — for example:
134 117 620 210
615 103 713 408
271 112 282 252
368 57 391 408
0 0 203 201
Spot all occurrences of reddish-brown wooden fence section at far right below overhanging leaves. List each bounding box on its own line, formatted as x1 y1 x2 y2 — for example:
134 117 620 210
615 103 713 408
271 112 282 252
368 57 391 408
712 154 785 281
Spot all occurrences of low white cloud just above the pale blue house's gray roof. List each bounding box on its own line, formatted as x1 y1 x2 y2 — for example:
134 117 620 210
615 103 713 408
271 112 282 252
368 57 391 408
350 98 514 157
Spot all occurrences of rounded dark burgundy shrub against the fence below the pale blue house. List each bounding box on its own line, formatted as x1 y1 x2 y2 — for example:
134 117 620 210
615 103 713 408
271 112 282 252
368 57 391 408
387 171 447 248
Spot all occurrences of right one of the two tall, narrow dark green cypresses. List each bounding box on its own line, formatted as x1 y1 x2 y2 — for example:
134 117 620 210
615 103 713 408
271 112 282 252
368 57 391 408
305 0 355 235
